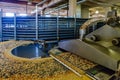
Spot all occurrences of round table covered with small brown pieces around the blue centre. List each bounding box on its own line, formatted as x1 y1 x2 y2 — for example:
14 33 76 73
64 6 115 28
0 40 92 80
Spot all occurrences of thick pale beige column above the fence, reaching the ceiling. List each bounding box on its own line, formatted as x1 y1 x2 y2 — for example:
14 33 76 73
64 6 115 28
69 0 77 17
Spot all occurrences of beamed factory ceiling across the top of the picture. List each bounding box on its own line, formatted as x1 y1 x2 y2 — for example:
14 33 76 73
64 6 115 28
0 0 120 14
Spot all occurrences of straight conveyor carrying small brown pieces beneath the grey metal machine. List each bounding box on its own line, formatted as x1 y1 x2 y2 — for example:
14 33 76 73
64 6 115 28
49 49 115 80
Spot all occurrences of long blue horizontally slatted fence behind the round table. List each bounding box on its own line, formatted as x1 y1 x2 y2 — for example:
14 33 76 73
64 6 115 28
0 16 87 41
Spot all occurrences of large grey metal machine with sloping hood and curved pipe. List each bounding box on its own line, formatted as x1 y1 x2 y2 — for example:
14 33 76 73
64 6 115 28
59 11 120 72
